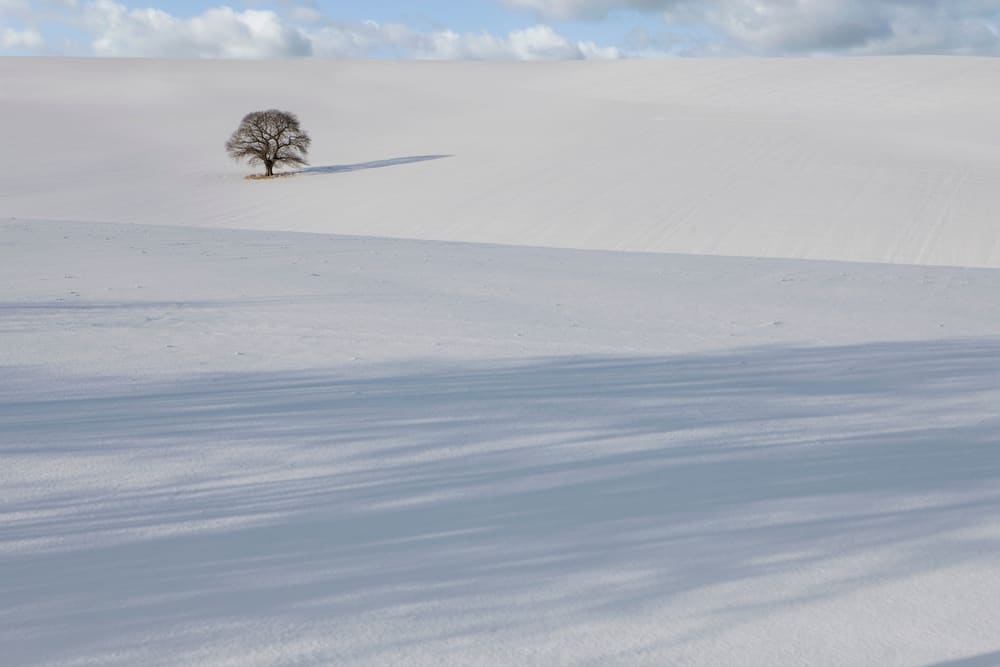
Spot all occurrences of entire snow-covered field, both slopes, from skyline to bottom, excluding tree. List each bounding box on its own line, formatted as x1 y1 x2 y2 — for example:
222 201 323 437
0 58 1000 667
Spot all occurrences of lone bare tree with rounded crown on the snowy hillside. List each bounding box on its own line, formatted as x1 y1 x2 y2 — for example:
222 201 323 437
226 109 312 176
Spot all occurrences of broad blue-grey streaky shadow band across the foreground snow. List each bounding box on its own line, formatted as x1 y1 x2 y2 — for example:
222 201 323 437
0 340 1000 664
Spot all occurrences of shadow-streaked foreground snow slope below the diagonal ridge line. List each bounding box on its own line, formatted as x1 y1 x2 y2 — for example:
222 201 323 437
0 221 1000 665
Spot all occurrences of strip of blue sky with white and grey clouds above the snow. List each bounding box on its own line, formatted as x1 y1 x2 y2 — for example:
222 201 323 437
0 0 1000 60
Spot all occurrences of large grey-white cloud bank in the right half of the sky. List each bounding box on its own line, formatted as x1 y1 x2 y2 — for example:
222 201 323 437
502 0 1000 55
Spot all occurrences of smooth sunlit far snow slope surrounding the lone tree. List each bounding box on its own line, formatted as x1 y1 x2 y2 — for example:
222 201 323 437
0 58 1000 267
